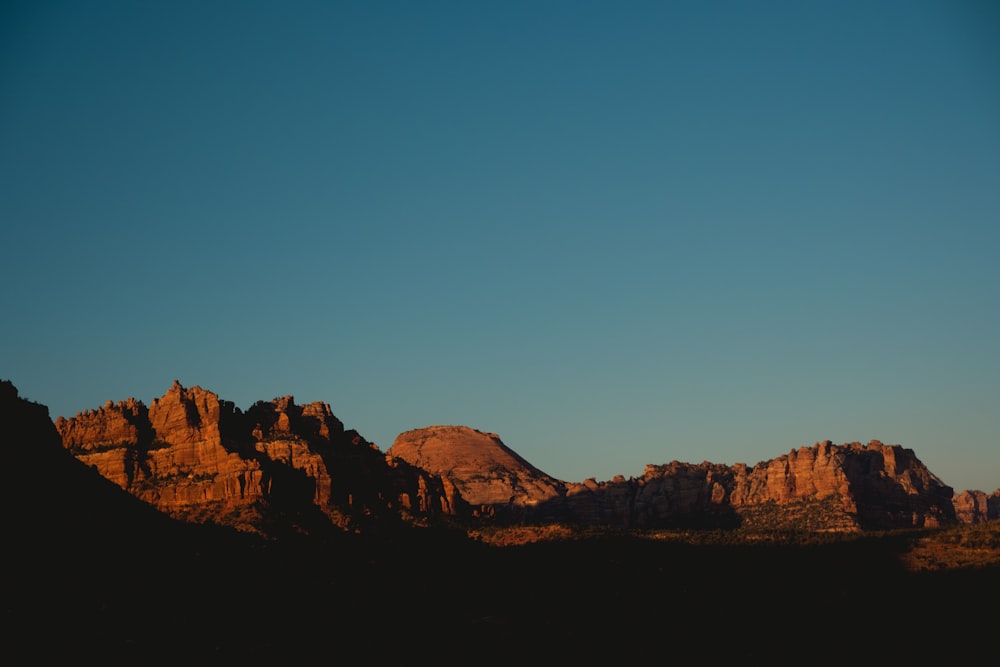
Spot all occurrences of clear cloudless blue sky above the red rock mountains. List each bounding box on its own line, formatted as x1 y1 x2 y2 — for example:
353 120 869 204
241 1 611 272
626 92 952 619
0 0 1000 491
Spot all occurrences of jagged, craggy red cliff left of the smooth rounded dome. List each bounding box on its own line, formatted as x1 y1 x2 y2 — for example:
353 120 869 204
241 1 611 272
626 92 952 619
55 381 458 528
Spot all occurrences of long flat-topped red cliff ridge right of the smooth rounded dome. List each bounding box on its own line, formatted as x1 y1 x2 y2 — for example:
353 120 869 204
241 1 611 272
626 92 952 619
566 441 957 531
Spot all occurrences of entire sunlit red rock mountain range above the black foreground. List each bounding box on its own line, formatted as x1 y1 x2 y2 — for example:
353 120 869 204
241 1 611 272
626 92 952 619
45 381 1000 533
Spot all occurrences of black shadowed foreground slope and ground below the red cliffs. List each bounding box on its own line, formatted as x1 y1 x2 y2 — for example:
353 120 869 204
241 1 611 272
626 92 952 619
0 384 1000 665
